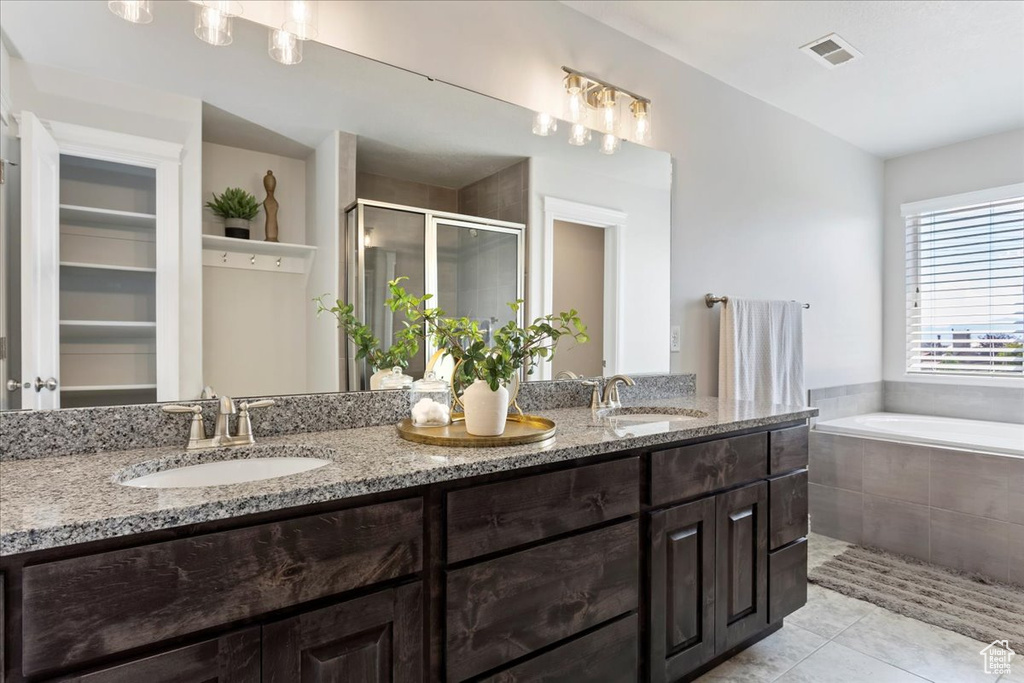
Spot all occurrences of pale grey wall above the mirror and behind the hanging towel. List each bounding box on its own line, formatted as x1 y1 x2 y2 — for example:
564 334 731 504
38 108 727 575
237 1 882 394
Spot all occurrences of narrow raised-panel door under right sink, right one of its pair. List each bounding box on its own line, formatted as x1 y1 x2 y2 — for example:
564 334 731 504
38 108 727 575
715 481 768 652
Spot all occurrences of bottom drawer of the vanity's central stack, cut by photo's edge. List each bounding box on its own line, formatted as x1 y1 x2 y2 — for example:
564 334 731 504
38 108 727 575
480 614 639 683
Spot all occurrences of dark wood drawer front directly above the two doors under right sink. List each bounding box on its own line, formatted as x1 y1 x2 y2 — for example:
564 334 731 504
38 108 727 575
650 433 768 505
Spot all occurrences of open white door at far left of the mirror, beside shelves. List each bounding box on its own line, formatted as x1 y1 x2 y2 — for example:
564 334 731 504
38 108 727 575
19 112 60 409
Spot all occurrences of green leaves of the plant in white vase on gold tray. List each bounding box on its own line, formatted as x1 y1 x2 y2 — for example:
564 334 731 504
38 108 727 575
387 278 589 391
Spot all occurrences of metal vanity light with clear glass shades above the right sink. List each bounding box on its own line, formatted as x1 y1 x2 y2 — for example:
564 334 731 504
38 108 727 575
534 67 650 155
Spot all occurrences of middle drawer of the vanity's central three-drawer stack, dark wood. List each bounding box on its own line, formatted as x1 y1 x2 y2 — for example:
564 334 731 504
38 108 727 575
445 519 640 681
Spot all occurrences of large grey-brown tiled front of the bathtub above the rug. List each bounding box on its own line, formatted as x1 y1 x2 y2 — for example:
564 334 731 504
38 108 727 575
809 430 1024 584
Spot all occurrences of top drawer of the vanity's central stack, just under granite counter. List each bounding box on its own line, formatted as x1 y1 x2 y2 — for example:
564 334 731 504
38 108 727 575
447 458 640 562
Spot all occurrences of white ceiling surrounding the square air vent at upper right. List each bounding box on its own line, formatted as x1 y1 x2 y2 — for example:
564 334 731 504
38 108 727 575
564 0 1024 158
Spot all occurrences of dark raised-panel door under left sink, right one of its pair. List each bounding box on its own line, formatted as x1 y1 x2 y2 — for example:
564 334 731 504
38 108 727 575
263 583 423 683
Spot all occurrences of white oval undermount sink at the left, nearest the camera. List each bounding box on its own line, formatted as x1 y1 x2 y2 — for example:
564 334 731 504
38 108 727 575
116 446 332 488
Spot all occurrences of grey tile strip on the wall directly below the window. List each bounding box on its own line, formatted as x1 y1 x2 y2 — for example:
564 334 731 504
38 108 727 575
880 382 1024 424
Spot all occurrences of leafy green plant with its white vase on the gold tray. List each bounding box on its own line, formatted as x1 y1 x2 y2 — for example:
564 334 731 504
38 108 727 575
387 278 589 436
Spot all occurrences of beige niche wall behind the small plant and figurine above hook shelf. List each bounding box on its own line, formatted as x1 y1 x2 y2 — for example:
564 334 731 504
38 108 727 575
203 142 306 245
